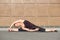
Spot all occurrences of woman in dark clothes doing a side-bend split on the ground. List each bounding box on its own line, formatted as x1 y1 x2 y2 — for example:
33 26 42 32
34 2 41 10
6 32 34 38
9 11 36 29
8 19 56 32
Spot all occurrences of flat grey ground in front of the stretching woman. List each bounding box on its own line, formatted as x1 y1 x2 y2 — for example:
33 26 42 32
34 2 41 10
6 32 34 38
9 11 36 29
0 31 60 40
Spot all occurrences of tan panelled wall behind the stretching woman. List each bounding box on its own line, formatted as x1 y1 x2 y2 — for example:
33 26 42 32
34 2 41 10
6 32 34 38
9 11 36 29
0 0 60 26
